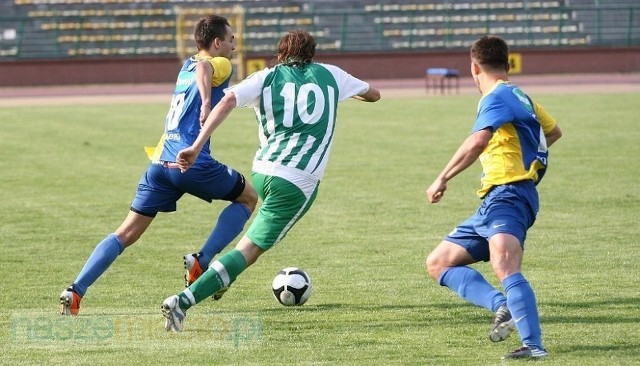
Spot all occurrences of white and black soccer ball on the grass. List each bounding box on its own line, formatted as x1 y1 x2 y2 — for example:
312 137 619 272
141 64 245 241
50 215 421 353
271 267 312 306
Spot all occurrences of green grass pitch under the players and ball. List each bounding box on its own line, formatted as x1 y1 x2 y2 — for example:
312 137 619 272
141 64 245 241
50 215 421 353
0 94 640 366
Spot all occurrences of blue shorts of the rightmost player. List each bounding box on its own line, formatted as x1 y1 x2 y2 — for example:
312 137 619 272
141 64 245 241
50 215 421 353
445 180 539 262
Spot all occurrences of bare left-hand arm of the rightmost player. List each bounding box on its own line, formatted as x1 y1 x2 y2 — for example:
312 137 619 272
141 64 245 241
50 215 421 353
426 128 493 203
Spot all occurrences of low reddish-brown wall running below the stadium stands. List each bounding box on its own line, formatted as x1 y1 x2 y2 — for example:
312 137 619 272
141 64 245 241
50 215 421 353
0 48 640 87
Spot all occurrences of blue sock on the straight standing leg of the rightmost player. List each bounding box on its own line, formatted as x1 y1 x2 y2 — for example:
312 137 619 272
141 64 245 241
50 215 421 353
502 273 543 348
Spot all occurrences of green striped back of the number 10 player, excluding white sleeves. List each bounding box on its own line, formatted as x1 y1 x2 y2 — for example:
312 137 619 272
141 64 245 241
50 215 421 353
256 63 338 180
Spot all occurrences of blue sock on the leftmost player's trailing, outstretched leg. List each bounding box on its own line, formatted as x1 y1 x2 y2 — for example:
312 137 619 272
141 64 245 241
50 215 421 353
73 234 124 297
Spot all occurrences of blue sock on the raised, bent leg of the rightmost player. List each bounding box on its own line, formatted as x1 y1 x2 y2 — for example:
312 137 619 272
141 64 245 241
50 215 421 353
438 266 507 313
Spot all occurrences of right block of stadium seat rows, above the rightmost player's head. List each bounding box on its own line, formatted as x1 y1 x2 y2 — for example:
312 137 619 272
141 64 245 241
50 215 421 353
365 1 588 49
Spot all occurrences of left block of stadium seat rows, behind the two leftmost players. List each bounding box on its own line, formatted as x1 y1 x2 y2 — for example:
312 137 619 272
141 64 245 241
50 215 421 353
3 0 322 58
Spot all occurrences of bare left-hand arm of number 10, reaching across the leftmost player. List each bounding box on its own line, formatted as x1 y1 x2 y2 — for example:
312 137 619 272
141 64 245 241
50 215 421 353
176 92 236 172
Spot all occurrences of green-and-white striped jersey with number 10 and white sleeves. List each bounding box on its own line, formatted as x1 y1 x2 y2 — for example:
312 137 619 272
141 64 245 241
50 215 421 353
226 63 369 185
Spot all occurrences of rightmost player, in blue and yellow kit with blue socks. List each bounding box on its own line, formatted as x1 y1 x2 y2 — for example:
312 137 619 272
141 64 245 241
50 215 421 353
426 36 562 358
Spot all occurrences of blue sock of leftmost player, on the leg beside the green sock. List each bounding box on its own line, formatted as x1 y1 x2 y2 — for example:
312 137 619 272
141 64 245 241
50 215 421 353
198 202 251 271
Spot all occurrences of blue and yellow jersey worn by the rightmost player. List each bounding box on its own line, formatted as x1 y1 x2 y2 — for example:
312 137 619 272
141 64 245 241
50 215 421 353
472 80 556 198
